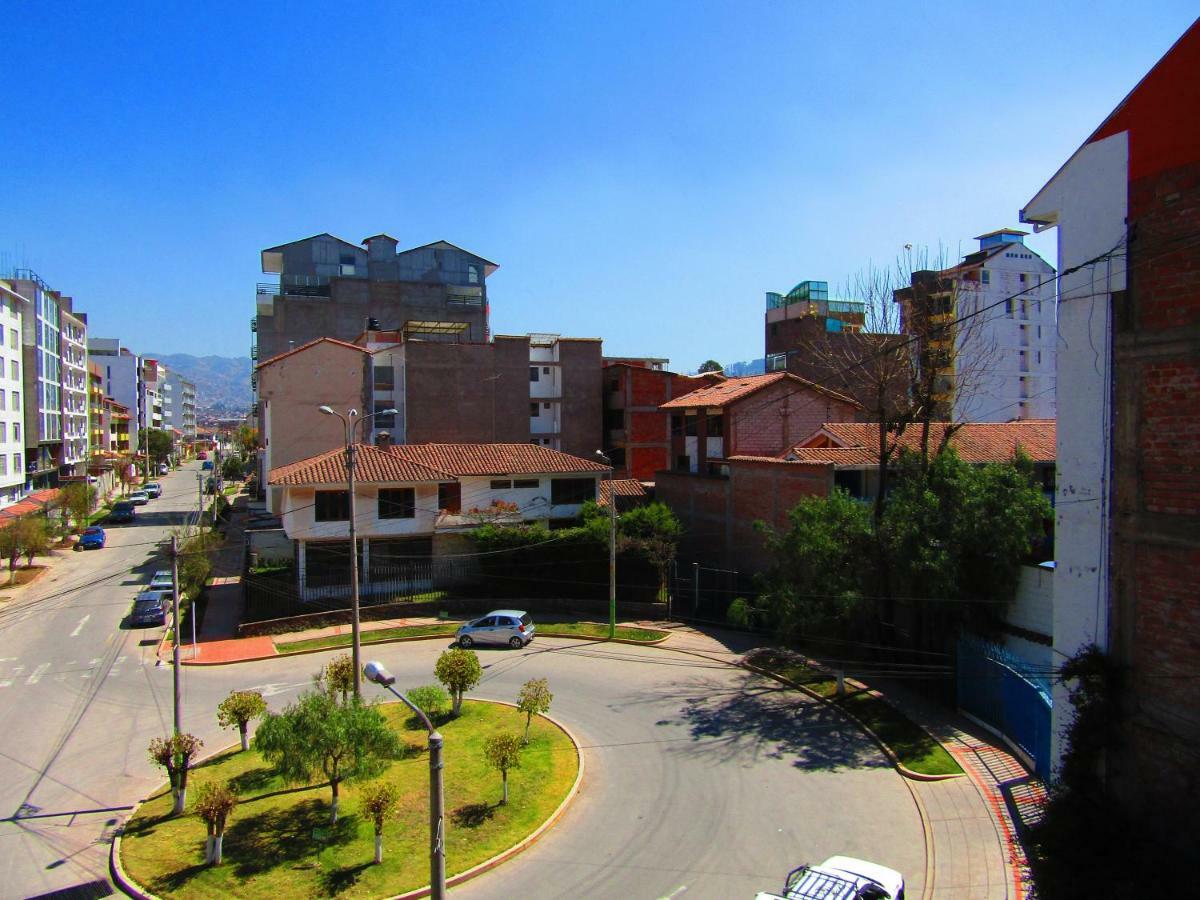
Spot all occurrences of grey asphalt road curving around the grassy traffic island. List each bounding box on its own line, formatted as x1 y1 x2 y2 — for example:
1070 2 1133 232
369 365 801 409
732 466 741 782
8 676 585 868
0 473 925 899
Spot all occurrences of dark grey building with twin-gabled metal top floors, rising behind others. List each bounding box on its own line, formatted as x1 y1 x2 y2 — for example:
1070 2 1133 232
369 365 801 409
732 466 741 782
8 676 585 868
251 234 499 360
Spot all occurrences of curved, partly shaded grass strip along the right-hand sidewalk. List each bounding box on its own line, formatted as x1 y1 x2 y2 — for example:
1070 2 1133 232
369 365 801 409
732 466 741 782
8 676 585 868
754 653 962 775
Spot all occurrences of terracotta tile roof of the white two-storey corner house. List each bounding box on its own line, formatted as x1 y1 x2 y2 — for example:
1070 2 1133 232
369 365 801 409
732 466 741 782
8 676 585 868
268 444 608 485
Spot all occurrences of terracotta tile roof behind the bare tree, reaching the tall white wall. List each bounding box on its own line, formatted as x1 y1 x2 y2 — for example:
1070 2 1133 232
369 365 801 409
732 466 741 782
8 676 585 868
785 419 1057 466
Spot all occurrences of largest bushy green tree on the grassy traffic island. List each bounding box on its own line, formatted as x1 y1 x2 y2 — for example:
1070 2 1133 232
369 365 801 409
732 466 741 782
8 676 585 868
253 690 401 823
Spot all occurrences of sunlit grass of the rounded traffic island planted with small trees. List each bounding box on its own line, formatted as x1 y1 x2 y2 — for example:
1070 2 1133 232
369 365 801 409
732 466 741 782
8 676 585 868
120 701 580 900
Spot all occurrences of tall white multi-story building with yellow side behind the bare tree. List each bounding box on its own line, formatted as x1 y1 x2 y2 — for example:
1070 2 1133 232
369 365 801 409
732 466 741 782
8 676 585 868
895 228 1057 422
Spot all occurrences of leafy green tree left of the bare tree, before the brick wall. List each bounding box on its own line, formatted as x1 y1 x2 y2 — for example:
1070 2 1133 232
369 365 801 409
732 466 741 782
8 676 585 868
762 491 871 640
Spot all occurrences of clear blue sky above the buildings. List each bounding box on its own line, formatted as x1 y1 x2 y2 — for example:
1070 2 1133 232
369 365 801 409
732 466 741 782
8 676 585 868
0 0 1195 371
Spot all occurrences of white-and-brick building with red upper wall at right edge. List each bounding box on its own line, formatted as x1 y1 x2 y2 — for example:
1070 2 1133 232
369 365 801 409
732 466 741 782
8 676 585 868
1021 22 1200 825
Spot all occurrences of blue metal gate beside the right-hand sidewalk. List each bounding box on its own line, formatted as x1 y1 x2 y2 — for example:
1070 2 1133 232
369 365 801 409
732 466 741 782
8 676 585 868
956 635 1054 779
